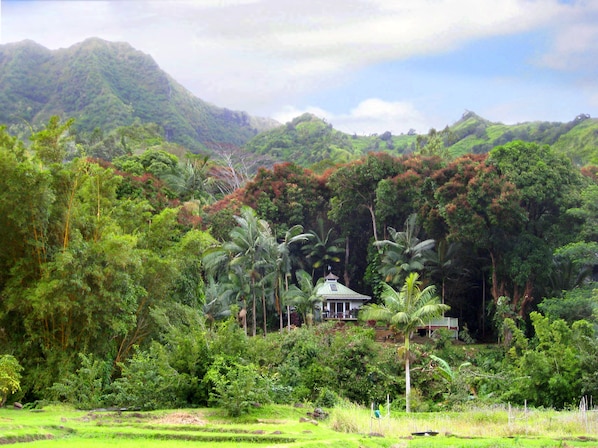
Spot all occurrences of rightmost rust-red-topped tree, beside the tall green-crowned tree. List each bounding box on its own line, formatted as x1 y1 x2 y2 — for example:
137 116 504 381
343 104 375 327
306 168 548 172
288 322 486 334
432 154 524 316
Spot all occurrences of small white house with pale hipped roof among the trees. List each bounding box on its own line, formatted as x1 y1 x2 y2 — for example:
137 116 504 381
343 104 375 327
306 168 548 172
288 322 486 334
318 272 371 321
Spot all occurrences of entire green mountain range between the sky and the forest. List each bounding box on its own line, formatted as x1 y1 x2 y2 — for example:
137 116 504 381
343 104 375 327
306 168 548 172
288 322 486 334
0 38 598 172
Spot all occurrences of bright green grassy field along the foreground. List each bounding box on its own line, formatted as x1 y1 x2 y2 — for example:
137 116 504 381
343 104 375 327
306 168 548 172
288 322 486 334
0 405 598 448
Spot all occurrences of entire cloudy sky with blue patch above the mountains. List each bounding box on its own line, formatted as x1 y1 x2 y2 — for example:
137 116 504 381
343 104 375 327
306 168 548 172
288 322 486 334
0 0 598 135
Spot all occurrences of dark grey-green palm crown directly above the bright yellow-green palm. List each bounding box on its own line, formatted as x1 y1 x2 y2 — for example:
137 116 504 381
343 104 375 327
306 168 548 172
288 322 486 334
374 213 434 285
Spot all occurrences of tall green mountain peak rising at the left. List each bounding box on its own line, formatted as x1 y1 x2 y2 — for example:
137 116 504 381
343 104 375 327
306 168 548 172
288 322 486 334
0 38 278 150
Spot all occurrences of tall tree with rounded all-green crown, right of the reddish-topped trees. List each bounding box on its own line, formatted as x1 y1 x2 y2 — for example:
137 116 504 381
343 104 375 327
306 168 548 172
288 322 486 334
486 141 582 316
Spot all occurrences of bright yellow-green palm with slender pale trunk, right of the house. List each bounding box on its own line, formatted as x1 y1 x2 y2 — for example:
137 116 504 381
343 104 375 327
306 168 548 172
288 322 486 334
360 272 450 412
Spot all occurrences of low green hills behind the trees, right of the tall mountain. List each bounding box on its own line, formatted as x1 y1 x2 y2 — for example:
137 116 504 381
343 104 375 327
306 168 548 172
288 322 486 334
245 112 598 169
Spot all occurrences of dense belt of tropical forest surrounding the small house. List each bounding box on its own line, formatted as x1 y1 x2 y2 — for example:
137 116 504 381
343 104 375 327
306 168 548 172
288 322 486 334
0 117 598 415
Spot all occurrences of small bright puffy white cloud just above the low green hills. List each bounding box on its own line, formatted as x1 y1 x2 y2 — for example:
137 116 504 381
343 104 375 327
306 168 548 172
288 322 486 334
273 98 429 135
